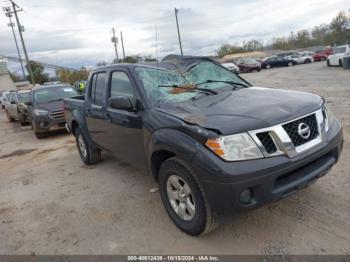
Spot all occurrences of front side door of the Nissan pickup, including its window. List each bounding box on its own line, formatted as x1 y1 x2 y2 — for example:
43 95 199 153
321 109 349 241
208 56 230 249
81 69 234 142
105 70 146 169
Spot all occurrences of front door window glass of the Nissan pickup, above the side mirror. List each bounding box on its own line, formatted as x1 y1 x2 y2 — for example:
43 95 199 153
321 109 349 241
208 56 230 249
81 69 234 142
110 72 134 98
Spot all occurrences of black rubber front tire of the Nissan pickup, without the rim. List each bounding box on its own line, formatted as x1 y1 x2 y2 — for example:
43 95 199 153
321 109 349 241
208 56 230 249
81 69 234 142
158 157 219 236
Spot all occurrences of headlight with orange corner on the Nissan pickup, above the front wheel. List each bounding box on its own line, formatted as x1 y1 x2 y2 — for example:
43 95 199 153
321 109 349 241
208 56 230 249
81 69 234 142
205 133 263 161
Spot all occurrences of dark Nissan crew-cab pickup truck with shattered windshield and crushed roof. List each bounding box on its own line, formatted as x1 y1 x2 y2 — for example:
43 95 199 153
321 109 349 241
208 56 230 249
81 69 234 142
64 56 343 235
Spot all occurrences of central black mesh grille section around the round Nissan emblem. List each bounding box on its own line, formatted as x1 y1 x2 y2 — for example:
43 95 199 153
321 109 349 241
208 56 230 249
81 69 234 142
282 114 318 147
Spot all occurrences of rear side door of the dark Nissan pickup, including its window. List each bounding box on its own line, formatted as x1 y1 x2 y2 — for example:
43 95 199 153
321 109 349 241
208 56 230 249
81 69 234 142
85 71 107 148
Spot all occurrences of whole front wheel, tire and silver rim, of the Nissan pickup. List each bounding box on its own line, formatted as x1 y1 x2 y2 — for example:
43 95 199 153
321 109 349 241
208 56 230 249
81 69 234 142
158 157 219 236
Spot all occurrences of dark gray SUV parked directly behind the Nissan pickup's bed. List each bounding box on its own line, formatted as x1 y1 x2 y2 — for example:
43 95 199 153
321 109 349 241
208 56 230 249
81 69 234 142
28 84 77 138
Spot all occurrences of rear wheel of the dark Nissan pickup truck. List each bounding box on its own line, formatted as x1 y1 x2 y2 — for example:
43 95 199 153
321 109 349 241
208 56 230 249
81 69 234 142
75 127 101 165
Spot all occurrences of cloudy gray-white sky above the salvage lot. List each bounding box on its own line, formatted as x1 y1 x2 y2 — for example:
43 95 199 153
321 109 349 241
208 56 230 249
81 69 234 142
0 0 350 71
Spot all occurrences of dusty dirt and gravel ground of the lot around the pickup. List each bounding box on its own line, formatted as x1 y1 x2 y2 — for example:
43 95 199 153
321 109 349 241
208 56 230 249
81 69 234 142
0 63 350 255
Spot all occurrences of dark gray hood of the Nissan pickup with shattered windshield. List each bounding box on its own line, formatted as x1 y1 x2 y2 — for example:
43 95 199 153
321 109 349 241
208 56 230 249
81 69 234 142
157 87 323 135
